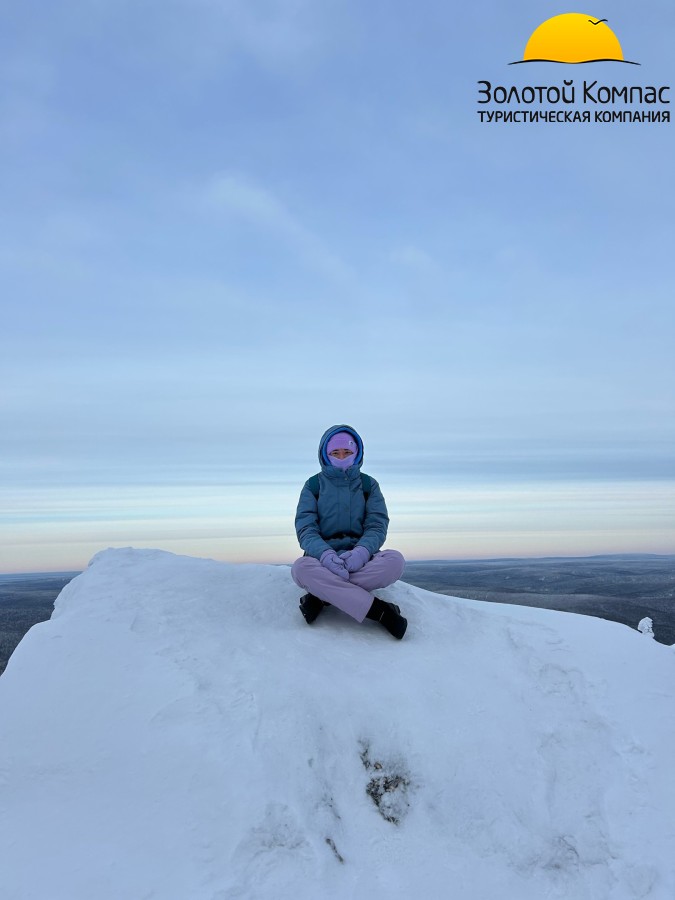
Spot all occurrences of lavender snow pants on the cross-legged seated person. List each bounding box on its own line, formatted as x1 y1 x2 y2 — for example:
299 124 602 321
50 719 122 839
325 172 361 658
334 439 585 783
291 550 405 622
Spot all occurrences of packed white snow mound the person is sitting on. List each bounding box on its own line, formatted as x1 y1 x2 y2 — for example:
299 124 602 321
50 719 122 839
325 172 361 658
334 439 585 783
0 550 675 900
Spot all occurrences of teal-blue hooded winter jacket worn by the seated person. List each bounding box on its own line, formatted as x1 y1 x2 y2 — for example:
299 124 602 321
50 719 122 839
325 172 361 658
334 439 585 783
295 425 389 559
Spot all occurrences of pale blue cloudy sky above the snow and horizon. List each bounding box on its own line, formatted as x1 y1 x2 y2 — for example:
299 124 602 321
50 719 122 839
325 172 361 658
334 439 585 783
0 0 675 571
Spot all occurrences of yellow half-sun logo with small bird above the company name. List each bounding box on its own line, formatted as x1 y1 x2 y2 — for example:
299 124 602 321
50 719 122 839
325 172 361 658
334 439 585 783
509 13 640 66
